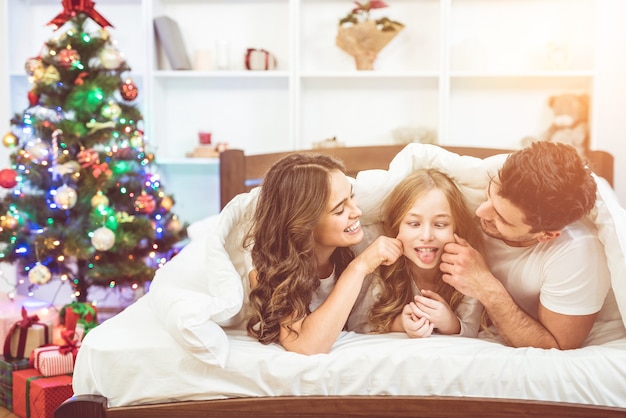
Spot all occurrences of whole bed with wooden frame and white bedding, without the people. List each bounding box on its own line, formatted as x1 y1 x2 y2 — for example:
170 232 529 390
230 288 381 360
55 144 626 418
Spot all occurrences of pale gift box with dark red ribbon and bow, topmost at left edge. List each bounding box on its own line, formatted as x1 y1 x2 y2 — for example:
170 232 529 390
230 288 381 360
3 307 53 359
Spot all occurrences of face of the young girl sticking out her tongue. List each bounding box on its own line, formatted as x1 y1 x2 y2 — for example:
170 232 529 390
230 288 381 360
397 189 455 269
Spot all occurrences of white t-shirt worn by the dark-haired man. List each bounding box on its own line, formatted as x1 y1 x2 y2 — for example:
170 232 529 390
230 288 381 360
484 217 611 319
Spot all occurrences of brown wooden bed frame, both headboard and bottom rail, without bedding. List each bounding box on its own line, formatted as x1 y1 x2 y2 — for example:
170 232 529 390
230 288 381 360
54 145 626 418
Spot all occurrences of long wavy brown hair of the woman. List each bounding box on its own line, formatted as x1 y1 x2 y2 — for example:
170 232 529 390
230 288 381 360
244 153 354 344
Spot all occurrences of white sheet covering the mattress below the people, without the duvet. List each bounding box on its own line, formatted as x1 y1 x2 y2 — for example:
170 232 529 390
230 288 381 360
73 294 626 407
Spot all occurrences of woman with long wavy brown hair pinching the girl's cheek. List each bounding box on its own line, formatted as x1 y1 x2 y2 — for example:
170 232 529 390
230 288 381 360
244 153 402 354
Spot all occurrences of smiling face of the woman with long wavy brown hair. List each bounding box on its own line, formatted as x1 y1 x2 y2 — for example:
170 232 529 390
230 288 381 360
313 170 363 252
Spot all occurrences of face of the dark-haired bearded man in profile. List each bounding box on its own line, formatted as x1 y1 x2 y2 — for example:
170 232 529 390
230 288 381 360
476 178 541 247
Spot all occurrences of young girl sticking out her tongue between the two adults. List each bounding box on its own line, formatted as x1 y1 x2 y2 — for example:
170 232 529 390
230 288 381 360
351 169 482 338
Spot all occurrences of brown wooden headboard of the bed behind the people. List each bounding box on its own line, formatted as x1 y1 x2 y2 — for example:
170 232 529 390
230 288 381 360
220 145 614 209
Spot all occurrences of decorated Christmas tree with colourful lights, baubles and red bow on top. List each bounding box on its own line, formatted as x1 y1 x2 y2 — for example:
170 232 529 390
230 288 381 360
0 0 186 301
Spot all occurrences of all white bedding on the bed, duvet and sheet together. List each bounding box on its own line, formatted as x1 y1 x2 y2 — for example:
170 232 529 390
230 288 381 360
73 144 626 407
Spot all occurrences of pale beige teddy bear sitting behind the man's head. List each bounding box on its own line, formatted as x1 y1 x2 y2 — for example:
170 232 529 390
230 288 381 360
528 93 589 156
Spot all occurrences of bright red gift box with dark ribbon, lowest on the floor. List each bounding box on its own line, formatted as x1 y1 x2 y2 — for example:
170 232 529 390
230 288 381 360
13 369 74 418
